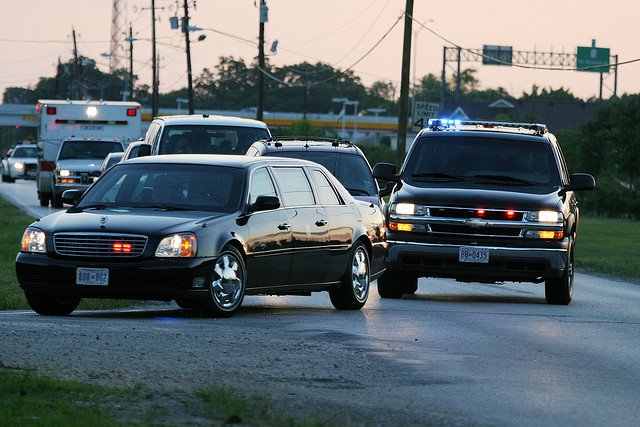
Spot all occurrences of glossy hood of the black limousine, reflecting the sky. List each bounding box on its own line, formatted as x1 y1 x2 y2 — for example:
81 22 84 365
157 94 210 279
34 208 228 235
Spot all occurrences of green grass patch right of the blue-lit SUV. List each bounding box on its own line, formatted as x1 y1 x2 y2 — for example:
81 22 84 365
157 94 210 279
576 216 640 281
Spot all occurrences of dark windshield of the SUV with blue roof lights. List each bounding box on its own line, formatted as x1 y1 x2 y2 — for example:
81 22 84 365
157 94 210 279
404 137 560 186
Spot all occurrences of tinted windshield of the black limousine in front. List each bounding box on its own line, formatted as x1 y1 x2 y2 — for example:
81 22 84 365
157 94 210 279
77 162 245 212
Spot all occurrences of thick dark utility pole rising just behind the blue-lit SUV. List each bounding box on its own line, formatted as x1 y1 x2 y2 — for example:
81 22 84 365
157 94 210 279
396 0 413 166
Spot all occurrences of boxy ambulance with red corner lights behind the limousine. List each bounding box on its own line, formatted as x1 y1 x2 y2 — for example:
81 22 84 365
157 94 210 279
36 99 142 208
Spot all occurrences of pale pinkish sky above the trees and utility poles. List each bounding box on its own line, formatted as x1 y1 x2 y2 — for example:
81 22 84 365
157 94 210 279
0 0 640 106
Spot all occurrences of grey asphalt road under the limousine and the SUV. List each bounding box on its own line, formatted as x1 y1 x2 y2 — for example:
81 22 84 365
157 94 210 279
0 179 640 426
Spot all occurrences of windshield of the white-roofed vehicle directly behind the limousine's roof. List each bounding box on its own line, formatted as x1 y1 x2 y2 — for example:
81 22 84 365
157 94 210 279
159 125 269 154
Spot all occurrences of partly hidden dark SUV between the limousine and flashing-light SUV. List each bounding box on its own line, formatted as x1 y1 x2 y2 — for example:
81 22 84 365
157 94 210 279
247 137 382 208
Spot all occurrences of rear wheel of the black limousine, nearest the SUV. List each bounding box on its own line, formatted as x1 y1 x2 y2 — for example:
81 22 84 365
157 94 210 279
329 242 371 310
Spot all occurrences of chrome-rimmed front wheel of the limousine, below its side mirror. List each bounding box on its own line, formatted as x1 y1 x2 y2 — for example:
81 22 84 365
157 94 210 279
209 246 247 317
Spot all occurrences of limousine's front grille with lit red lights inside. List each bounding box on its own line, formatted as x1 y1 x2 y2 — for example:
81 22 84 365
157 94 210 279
53 233 147 258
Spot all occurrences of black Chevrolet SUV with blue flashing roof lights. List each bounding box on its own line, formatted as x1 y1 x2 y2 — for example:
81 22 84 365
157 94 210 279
373 120 595 304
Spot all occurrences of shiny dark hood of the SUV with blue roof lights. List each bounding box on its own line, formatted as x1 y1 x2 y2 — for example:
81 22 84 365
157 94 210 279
391 183 562 210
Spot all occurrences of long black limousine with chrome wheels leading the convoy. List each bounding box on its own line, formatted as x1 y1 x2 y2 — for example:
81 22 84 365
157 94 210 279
16 155 386 317
